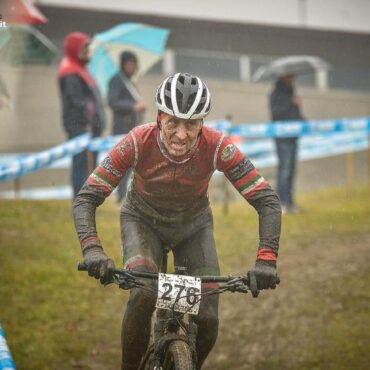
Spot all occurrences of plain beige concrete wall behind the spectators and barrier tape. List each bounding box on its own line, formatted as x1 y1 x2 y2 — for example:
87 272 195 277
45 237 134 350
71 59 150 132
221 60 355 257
0 66 370 152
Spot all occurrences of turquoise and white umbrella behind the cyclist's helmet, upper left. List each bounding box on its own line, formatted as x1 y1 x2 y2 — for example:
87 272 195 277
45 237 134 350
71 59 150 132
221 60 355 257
89 22 169 95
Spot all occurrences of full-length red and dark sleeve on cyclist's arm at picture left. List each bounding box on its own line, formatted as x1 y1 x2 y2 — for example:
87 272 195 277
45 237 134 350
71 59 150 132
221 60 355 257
73 132 137 250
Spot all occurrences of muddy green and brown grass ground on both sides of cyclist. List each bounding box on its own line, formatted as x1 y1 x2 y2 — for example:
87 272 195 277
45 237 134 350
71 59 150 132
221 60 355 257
0 187 370 370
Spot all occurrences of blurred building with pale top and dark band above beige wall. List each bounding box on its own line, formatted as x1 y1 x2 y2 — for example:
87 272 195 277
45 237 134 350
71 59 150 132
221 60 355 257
35 0 370 91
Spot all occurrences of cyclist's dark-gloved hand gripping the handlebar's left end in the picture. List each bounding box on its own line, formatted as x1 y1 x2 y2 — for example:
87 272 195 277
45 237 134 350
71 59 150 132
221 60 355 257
83 246 115 284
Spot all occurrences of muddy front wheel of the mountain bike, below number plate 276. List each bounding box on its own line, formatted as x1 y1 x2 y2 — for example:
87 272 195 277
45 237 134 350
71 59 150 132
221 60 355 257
163 340 195 370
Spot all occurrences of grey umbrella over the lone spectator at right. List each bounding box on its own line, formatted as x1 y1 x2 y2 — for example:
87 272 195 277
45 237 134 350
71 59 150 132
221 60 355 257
252 55 330 81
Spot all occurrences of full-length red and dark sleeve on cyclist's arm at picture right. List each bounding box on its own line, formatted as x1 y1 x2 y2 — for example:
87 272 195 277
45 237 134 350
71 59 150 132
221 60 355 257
216 138 281 261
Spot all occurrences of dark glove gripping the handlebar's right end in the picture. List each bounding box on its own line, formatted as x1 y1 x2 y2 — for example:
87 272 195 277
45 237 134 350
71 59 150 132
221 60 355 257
248 260 280 298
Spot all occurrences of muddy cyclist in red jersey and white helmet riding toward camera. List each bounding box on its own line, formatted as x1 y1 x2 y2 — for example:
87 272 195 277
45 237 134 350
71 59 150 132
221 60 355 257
74 73 281 370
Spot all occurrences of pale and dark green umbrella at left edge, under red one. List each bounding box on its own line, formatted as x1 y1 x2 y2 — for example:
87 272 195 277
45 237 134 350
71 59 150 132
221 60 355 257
0 25 57 65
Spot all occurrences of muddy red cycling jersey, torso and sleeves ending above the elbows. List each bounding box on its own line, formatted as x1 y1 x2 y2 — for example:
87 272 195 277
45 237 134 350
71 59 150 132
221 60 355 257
88 123 268 207
